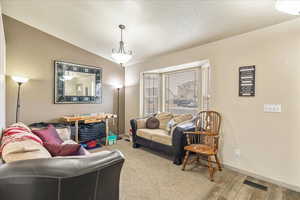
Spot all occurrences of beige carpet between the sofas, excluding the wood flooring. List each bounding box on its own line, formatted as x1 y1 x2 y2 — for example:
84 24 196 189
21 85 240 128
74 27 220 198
95 141 215 200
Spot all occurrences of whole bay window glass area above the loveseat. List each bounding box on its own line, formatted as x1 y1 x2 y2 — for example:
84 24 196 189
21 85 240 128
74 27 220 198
141 67 202 116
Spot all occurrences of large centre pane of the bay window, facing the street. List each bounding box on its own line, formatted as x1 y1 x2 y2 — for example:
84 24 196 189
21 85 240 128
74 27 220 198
164 69 200 114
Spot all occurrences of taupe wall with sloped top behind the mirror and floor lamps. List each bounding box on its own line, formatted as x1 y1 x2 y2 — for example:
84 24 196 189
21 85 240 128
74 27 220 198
4 16 124 134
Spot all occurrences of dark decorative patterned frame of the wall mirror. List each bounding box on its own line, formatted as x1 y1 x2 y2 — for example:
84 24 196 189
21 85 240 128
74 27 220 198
54 60 102 104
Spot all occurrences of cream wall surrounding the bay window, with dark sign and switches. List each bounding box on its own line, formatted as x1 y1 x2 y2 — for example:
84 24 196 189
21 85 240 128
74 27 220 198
125 19 300 190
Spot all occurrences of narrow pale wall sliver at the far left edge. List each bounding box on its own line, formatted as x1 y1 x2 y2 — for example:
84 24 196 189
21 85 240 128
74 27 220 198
0 4 5 131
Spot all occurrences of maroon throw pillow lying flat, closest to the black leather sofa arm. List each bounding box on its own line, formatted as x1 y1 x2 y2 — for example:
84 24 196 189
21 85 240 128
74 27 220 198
44 142 81 156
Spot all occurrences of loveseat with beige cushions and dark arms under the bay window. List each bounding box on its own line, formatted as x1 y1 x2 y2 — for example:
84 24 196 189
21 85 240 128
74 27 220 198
130 112 194 164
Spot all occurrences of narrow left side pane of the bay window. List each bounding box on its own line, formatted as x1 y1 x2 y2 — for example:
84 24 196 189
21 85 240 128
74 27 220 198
143 74 161 115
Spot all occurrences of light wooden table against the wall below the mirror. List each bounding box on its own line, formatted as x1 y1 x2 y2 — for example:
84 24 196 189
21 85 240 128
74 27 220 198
62 113 117 145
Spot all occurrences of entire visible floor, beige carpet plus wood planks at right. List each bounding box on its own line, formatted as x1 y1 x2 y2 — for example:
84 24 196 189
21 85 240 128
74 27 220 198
94 141 300 200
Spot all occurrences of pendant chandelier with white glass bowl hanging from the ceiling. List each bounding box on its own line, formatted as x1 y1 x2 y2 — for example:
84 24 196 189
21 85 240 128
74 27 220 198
111 24 132 65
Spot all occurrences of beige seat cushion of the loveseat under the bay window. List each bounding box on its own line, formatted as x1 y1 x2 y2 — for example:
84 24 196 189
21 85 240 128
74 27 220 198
136 129 172 146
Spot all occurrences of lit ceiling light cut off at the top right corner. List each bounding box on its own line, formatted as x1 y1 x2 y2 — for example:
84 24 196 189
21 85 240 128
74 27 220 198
275 0 300 15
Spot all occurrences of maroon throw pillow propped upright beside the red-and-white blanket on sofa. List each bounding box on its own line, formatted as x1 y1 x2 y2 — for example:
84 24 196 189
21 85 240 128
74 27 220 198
32 124 64 144
